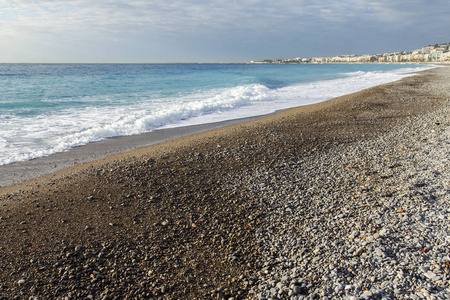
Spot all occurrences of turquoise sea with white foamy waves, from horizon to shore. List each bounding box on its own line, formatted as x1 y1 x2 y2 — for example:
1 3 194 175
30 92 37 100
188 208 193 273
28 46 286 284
0 64 433 165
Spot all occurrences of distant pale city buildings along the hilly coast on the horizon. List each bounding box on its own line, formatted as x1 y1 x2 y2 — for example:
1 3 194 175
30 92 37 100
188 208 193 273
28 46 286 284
251 43 450 64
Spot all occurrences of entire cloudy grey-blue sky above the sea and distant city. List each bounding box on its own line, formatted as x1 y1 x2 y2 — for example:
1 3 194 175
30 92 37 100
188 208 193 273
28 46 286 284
0 0 450 63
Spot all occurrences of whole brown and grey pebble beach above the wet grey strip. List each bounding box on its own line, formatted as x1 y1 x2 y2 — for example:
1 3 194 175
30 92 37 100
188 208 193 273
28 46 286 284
0 67 450 300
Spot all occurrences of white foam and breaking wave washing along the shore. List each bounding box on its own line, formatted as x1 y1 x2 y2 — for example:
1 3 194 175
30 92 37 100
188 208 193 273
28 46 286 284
0 67 436 165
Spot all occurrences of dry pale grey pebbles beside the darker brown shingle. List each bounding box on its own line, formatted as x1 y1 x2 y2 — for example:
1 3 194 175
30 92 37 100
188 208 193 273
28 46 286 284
234 75 450 299
